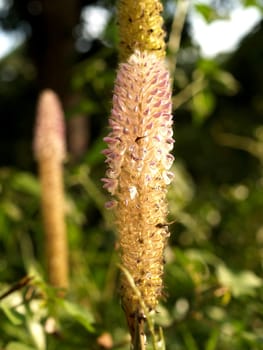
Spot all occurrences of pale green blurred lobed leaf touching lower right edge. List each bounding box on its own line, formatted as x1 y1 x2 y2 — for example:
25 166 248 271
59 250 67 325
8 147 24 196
217 265 262 298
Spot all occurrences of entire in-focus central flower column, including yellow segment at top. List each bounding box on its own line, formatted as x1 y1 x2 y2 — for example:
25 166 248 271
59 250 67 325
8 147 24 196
102 0 174 344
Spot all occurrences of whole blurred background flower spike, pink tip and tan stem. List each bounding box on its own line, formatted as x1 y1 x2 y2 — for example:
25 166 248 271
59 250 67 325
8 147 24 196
33 90 68 288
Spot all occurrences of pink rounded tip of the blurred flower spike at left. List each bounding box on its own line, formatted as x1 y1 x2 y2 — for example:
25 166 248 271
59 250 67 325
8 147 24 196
33 90 66 161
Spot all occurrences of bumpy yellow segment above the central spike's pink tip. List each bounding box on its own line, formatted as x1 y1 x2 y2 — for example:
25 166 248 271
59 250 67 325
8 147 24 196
118 0 165 61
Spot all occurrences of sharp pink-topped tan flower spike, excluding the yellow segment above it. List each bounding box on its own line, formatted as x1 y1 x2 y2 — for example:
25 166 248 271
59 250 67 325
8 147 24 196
102 51 174 332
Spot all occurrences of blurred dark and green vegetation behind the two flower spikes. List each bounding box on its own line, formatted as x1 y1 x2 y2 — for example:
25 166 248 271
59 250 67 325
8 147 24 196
0 0 263 350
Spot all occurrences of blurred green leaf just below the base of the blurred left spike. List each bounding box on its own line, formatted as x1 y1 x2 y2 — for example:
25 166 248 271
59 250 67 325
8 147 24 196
61 300 94 332
